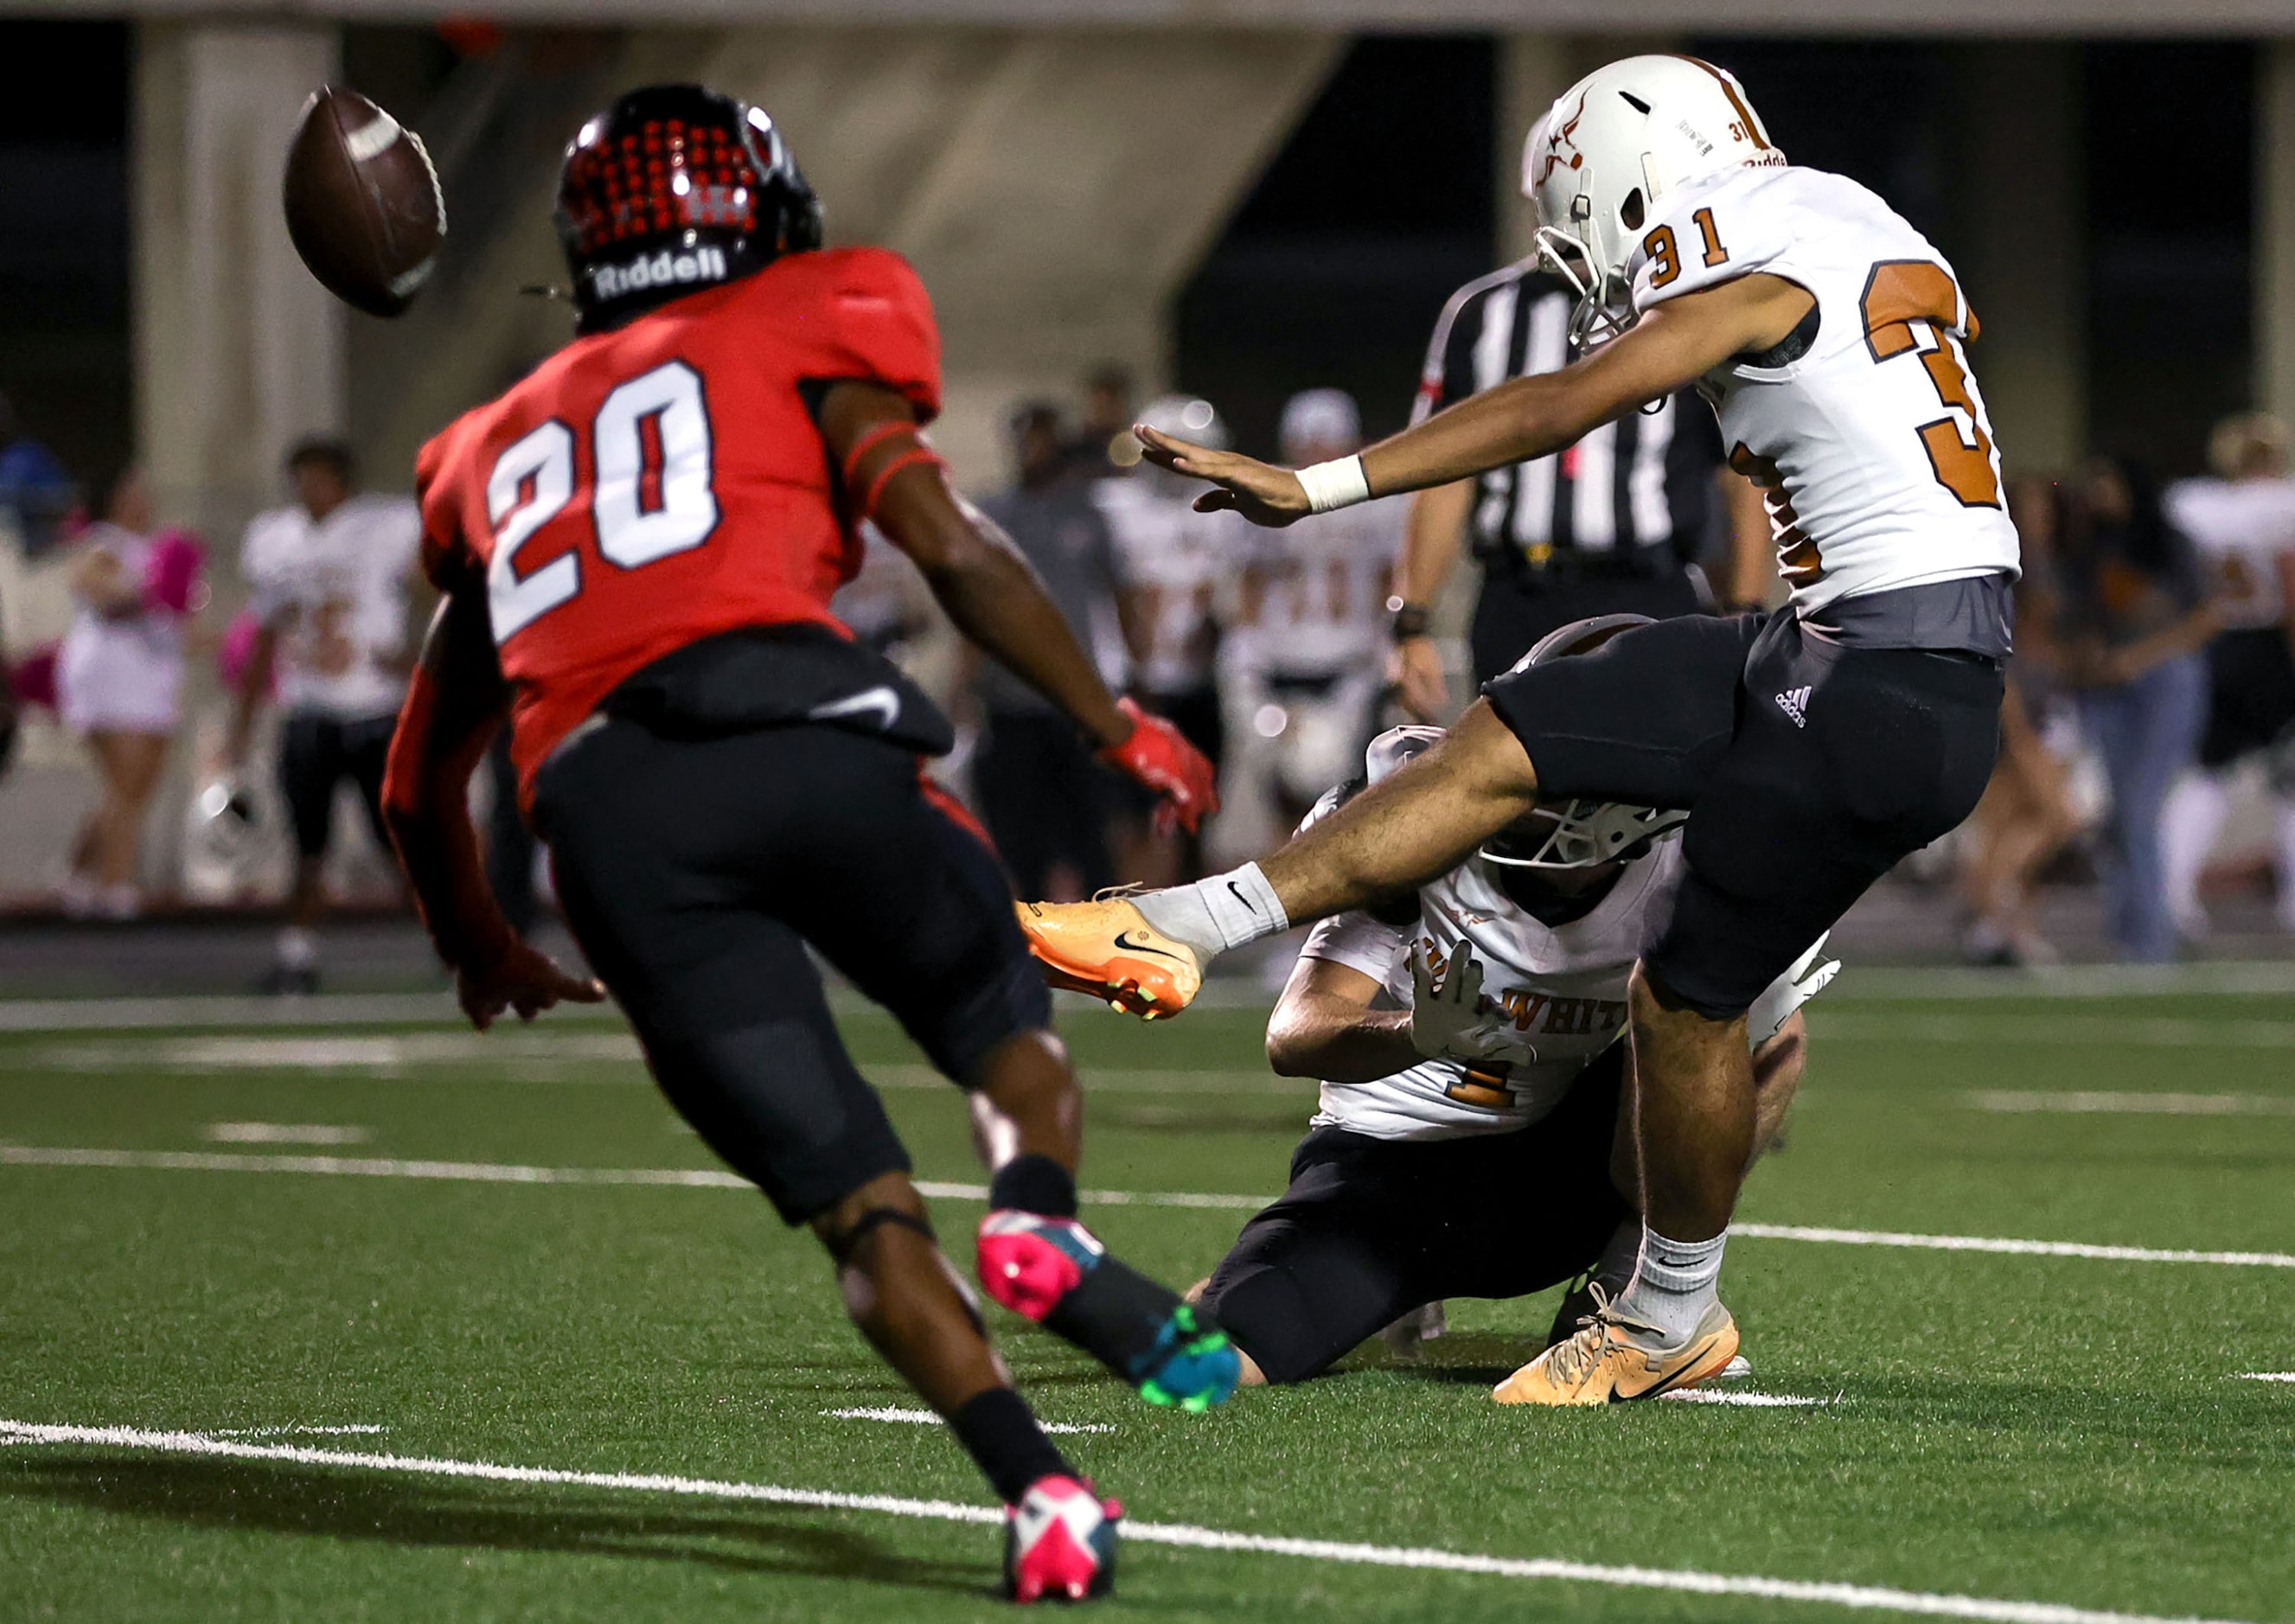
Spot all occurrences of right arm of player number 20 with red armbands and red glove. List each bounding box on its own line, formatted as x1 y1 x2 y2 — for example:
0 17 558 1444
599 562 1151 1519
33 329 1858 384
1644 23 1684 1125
819 380 1218 830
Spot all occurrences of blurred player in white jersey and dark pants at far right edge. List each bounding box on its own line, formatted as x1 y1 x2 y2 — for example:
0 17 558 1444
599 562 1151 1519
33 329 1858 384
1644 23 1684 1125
2162 412 2295 941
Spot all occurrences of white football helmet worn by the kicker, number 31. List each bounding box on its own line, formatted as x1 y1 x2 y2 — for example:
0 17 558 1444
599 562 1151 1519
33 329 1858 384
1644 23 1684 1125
1522 55 1786 344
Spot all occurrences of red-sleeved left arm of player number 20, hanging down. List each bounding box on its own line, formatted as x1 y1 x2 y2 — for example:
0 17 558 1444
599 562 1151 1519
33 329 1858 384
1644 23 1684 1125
383 587 606 1033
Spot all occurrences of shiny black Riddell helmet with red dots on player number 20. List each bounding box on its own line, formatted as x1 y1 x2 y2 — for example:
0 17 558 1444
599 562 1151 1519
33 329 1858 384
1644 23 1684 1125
555 85 821 333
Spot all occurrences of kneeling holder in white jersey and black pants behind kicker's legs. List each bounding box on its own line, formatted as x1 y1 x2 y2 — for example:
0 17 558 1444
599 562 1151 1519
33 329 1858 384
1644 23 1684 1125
1198 615 1841 1403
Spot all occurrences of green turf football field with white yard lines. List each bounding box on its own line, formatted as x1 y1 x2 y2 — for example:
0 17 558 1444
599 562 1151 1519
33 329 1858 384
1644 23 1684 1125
0 973 2295 1624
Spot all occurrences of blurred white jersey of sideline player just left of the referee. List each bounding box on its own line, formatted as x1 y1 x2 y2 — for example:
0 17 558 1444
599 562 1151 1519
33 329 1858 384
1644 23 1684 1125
1237 498 1407 677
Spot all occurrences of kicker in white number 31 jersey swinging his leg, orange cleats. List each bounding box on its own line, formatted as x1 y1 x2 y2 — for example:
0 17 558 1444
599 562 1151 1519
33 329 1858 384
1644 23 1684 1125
1028 55 2020 1403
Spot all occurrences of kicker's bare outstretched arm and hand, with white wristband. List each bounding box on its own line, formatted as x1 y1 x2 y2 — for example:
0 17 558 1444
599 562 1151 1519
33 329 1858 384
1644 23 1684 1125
1134 273 1815 525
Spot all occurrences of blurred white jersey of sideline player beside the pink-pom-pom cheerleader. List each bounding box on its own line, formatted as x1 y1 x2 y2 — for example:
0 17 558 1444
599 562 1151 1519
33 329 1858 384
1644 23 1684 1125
239 496 422 720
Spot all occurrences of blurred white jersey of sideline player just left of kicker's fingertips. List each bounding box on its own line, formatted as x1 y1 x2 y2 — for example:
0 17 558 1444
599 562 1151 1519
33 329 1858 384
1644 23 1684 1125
1092 472 1249 693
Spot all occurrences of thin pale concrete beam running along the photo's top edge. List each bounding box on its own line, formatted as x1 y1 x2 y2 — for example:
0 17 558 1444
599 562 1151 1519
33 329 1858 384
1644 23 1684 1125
27 0 2295 36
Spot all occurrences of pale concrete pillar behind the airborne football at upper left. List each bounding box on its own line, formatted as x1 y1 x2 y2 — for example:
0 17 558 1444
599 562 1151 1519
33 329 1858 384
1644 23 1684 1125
133 23 347 534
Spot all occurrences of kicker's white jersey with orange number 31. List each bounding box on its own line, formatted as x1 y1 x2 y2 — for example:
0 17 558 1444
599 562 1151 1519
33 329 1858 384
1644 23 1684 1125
1627 168 2017 615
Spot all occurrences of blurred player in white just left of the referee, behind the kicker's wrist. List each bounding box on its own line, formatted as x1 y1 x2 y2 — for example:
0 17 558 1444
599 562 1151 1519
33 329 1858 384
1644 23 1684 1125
1218 390 1403 855
